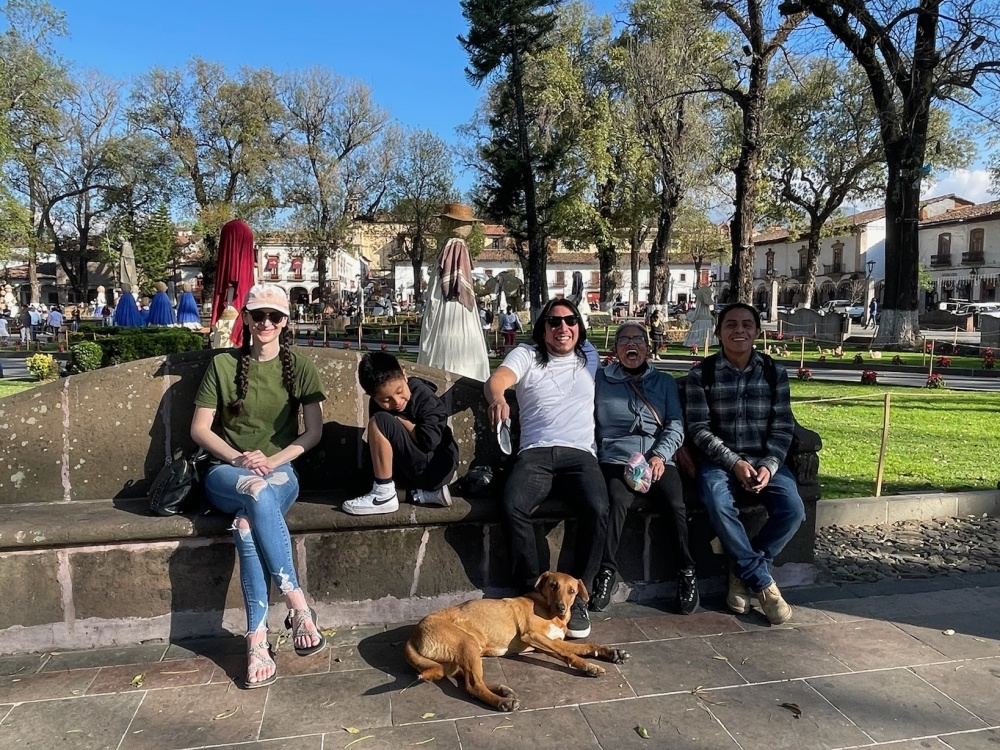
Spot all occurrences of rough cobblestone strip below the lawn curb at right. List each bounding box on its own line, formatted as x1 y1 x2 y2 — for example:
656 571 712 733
816 516 1000 582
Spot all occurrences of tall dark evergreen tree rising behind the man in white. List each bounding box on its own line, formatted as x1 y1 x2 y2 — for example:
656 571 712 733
459 0 557 315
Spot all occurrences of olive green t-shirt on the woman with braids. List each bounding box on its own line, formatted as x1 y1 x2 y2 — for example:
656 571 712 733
194 350 326 456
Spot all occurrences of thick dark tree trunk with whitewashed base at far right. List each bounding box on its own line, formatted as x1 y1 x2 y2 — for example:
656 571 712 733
875 158 923 348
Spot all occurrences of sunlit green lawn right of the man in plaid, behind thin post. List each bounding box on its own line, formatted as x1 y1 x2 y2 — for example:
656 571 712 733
791 380 1000 498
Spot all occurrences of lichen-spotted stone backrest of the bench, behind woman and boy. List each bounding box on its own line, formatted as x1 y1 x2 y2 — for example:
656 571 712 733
0 347 504 505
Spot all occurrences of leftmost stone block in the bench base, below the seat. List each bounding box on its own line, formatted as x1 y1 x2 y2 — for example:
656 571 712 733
0 550 64 630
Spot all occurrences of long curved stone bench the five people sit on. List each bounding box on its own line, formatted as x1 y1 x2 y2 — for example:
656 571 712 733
0 348 819 653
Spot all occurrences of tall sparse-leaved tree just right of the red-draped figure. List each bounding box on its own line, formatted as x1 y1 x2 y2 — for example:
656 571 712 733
280 68 395 297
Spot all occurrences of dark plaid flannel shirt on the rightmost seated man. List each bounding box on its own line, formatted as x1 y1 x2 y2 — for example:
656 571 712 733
684 351 795 476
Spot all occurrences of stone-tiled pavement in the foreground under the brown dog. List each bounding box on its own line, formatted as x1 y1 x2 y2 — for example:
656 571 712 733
0 573 1000 750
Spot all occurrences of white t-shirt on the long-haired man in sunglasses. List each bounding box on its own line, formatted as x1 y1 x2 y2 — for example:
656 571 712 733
502 341 598 456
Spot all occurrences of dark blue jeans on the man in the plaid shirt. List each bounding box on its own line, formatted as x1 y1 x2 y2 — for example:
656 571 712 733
698 461 806 591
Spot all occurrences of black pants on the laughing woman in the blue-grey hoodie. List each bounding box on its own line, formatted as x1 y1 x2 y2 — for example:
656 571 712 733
601 464 694 571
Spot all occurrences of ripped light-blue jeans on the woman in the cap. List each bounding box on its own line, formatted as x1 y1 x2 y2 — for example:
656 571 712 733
205 463 299 634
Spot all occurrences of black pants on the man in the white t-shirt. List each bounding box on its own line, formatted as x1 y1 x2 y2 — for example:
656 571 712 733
503 448 608 591
